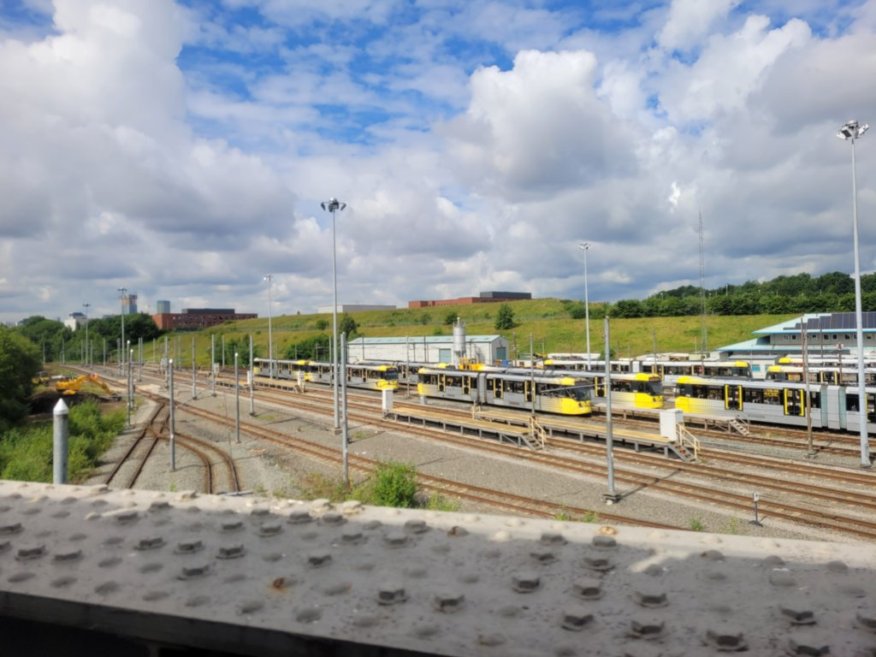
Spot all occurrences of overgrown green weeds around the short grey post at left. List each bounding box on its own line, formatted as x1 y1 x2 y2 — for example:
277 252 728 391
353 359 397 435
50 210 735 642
0 401 125 482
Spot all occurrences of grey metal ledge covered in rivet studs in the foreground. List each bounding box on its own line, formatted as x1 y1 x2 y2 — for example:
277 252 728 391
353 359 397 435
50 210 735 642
0 482 876 657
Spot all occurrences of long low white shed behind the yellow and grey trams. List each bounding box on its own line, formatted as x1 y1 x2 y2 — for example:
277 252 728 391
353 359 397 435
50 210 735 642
347 335 508 365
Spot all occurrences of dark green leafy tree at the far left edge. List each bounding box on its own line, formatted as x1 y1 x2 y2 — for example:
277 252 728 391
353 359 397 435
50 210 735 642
0 326 41 432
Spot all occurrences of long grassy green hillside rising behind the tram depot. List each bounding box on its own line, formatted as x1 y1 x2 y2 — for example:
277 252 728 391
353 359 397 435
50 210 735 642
151 299 794 367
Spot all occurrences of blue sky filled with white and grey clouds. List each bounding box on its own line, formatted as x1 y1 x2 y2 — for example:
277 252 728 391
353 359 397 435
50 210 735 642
0 0 876 322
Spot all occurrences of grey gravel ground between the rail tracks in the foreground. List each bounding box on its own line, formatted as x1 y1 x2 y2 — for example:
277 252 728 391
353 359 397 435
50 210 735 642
88 385 848 540
